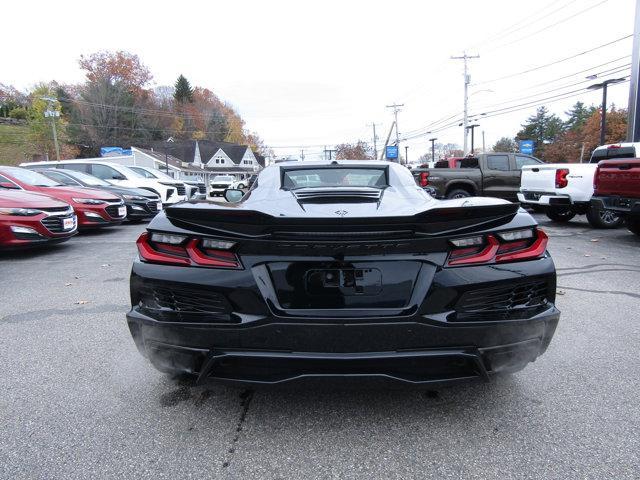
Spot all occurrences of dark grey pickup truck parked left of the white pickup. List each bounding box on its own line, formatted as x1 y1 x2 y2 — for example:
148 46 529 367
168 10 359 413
411 152 543 202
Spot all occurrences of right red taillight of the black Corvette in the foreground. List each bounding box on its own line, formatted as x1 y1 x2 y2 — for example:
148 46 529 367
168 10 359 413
447 228 548 267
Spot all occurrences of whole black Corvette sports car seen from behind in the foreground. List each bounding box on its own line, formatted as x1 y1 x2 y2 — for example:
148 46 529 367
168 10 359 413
127 161 559 385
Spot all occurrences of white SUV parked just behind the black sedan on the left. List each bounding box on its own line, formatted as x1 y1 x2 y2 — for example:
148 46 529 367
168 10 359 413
20 160 187 205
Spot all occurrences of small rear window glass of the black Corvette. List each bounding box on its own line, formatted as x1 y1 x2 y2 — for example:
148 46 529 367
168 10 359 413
282 167 388 190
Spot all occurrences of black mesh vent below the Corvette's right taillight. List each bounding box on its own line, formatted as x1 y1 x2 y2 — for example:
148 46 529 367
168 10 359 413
453 280 549 322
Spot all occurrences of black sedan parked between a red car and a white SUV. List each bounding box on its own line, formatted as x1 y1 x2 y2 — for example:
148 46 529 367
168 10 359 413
35 168 162 221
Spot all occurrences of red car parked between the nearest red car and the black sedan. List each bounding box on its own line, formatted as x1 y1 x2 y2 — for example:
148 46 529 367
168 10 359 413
0 167 127 230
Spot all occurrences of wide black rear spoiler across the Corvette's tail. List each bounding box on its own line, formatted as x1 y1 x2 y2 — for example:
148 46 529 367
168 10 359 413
165 203 520 238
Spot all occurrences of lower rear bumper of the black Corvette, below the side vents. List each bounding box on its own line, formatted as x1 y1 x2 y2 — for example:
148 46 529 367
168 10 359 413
127 306 559 385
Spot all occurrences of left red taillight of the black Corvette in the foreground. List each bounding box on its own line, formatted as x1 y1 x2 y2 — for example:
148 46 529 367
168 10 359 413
136 232 242 269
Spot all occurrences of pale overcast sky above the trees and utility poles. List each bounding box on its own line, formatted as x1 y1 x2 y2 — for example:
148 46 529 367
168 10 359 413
0 0 635 160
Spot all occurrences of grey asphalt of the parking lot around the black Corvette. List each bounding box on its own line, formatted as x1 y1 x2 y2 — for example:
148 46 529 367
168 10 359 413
0 215 640 479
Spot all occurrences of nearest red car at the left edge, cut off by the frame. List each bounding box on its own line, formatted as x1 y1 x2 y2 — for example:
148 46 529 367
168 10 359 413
0 187 78 249
